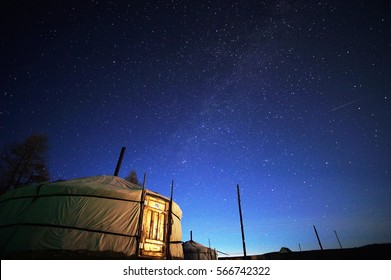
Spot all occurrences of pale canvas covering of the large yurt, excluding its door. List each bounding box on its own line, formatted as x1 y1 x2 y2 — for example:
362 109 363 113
0 176 183 259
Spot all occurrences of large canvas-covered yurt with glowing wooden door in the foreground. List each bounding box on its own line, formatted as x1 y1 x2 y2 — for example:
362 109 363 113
0 176 184 259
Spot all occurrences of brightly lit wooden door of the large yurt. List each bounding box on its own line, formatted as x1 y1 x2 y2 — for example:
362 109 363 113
140 195 168 258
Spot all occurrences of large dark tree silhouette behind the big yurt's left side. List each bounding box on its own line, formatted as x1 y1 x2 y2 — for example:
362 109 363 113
0 134 50 192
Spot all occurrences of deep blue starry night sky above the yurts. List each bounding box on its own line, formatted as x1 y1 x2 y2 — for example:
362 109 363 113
0 0 391 255
